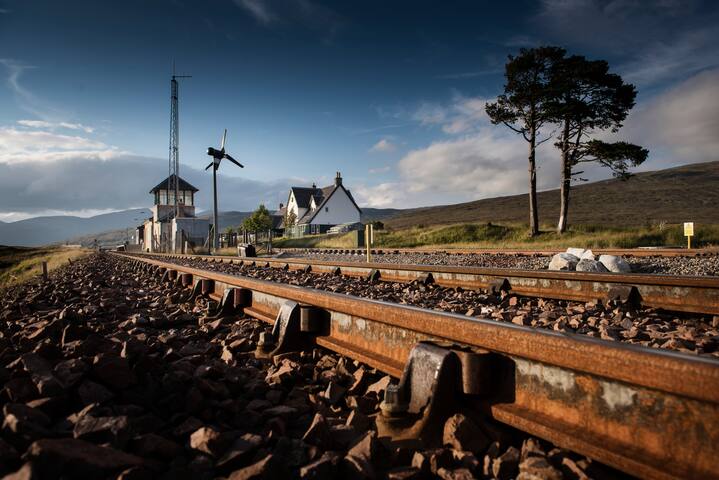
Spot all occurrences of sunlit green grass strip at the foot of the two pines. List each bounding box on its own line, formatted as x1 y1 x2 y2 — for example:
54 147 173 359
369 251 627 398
273 223 719 249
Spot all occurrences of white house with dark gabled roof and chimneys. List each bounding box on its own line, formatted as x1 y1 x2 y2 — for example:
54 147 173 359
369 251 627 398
285 172 362 233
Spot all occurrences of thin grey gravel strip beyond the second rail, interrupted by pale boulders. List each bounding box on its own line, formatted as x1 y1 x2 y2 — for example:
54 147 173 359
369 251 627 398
285 252 719 276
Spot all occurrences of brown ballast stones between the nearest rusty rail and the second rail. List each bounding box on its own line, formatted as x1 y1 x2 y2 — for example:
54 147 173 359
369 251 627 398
148 257 719 358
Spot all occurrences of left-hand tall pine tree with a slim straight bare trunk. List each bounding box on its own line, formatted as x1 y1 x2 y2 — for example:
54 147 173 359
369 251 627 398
485 47 565 236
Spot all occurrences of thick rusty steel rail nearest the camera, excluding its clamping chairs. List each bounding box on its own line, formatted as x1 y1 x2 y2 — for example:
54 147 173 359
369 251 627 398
116 254 719 479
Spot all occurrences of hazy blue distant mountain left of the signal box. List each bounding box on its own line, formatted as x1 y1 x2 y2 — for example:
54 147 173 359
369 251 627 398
0 208 150 247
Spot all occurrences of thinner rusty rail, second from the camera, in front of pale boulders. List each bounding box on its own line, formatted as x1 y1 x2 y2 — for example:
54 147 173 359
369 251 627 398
141 254 719 315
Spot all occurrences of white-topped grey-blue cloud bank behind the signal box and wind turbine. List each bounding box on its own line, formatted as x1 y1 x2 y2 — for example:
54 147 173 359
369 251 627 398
0 121 289 220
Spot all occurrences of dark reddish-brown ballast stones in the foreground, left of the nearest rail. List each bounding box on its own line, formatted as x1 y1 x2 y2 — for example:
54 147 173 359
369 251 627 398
0 255 632 480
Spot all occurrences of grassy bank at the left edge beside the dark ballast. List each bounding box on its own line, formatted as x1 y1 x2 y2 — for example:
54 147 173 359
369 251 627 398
0 246 91 287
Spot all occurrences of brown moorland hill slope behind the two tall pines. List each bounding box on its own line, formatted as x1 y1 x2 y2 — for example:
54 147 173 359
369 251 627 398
384 162 719 229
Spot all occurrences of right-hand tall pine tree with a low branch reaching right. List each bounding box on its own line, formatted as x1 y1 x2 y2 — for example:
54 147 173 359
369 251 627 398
546 55 649 233
